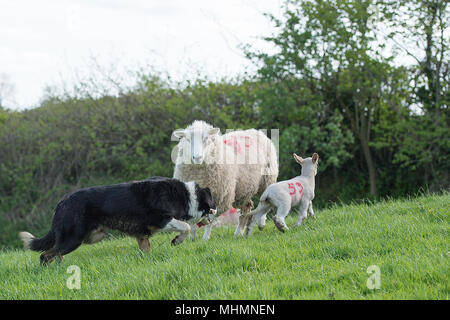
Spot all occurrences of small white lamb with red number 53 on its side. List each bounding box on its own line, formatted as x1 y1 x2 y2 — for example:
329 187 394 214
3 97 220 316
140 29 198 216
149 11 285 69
246 153 319 236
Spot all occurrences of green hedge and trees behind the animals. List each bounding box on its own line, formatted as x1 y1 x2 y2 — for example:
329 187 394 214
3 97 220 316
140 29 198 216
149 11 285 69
0 0 450 247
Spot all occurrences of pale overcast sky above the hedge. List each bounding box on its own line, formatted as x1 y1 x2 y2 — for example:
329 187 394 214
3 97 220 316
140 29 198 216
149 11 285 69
0 0 282 109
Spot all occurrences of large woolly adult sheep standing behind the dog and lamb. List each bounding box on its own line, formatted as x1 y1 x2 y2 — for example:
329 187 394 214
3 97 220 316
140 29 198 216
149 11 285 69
173 120 278 240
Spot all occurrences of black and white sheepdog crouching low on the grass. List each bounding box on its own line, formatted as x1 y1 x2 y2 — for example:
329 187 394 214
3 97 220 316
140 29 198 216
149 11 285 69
19 177 216 264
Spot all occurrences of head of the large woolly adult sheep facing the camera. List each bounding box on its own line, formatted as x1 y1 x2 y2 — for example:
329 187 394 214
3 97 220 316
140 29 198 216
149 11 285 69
173 120 220 164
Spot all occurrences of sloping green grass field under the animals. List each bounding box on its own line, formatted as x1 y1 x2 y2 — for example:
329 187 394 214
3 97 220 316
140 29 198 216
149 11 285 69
0 194 450 299
